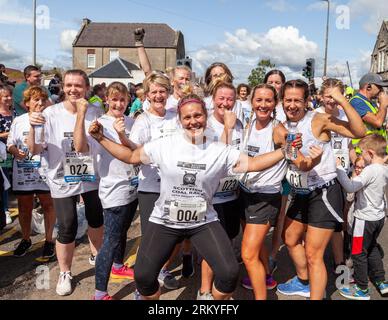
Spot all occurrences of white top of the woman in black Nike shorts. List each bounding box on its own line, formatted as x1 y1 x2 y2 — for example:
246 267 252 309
241 120 287 194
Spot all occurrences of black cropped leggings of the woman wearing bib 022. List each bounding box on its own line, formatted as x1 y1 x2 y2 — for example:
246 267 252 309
53 190 104 244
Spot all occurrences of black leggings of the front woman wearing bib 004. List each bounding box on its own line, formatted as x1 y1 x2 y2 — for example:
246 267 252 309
135 221 239 296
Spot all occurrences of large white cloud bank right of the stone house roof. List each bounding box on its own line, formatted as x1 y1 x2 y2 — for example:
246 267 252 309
190 26 318 83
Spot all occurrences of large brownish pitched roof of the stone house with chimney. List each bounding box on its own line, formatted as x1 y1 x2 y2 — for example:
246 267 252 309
73 19 179 48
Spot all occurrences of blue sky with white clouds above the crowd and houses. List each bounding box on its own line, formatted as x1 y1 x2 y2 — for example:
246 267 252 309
0 0 388 86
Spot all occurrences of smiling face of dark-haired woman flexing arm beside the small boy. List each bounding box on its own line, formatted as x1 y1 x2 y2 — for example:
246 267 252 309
283 88 308 122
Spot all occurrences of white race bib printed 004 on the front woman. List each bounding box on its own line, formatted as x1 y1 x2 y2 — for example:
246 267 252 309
170 198 207 223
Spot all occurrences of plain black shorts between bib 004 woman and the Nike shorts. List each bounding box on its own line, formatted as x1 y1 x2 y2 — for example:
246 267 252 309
213 199 243 239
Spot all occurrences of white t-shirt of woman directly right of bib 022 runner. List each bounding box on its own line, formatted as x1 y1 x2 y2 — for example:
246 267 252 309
89 114 137 209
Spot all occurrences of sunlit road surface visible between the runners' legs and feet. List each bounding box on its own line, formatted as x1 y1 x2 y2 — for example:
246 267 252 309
0 192 388 300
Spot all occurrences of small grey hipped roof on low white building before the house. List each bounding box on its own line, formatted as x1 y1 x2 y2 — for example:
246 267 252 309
89 57 140 79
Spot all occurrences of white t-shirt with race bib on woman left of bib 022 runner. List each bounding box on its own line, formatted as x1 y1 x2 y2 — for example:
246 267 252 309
7 113 50 191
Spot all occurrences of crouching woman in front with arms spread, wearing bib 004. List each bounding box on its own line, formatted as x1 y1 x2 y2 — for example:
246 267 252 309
89 95 318 300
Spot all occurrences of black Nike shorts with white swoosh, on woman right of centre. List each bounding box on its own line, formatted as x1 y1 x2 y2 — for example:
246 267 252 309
241 191 282 227
